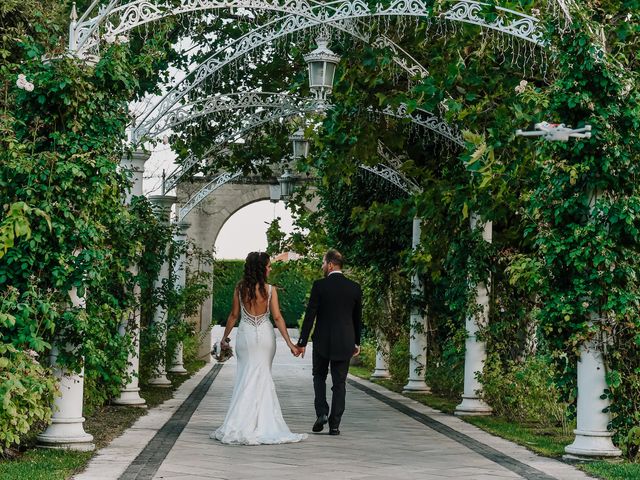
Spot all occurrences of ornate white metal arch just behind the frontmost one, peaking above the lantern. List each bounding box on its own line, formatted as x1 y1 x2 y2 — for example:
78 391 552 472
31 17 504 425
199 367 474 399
132 15 429 143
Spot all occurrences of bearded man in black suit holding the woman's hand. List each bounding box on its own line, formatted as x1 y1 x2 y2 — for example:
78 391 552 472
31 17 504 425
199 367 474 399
298 250 362 435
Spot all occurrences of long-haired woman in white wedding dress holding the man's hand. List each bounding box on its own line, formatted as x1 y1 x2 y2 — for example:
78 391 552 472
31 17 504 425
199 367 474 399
209 252 307 445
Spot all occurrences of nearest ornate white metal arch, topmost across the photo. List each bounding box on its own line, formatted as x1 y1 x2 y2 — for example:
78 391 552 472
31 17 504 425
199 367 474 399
75 0 543 57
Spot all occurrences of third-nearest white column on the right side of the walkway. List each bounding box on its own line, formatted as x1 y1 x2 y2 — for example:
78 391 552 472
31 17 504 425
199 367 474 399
404 218 431 392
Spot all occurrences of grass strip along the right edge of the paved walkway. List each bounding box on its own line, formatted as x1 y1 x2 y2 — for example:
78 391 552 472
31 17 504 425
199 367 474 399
349 366 640 480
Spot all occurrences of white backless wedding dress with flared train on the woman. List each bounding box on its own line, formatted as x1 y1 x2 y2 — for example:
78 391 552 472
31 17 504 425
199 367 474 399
209 285 307 445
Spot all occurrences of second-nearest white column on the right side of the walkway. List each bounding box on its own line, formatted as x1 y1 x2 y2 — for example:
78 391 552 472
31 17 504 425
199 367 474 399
455 214 493 415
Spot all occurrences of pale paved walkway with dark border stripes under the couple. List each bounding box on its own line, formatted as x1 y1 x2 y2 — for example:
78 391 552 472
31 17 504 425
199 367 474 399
74 332 590 480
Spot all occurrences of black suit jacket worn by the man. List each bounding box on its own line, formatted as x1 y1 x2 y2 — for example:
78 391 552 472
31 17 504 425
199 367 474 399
298 273 362 360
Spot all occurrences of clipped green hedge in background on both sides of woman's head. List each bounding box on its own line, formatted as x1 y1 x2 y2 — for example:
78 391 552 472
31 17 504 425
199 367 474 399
213 260 312 328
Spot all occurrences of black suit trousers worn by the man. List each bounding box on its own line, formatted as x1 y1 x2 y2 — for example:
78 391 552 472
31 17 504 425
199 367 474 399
312 349 350 428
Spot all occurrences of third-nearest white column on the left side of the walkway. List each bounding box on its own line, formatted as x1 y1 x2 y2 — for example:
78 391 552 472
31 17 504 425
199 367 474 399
149 195 177 387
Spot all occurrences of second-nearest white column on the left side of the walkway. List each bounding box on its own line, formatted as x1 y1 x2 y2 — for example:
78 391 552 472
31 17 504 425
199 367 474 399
113 150 150 407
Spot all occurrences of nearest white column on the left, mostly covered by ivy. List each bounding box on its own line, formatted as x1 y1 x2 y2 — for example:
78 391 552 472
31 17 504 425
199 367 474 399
38 287 95 452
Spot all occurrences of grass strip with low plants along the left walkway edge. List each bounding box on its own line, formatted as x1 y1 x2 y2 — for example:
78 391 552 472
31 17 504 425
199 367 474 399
0 361 205 480
